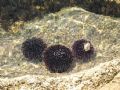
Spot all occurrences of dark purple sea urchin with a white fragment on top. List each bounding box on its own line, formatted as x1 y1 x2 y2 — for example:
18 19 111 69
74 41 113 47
72 39 94 62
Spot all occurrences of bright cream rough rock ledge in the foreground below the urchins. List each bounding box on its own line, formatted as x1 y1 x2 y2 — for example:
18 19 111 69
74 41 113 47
0 59 120 90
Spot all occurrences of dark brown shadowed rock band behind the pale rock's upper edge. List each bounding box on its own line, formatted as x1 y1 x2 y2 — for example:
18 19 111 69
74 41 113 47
0 0 120 31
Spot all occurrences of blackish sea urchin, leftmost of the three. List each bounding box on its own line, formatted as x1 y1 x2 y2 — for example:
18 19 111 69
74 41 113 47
22 37 46 60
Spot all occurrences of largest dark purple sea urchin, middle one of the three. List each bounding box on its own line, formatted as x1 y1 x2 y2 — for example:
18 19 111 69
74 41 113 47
44 45 73 73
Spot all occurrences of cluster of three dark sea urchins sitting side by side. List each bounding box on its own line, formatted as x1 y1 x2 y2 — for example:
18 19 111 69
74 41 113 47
22 37 94 73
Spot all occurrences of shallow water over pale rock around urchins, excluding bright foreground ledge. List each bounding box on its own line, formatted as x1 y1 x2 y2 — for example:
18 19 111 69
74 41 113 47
0 7 120 77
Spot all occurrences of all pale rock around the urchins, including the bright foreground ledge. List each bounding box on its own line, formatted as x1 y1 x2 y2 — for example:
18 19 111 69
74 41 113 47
0 7 120 90
